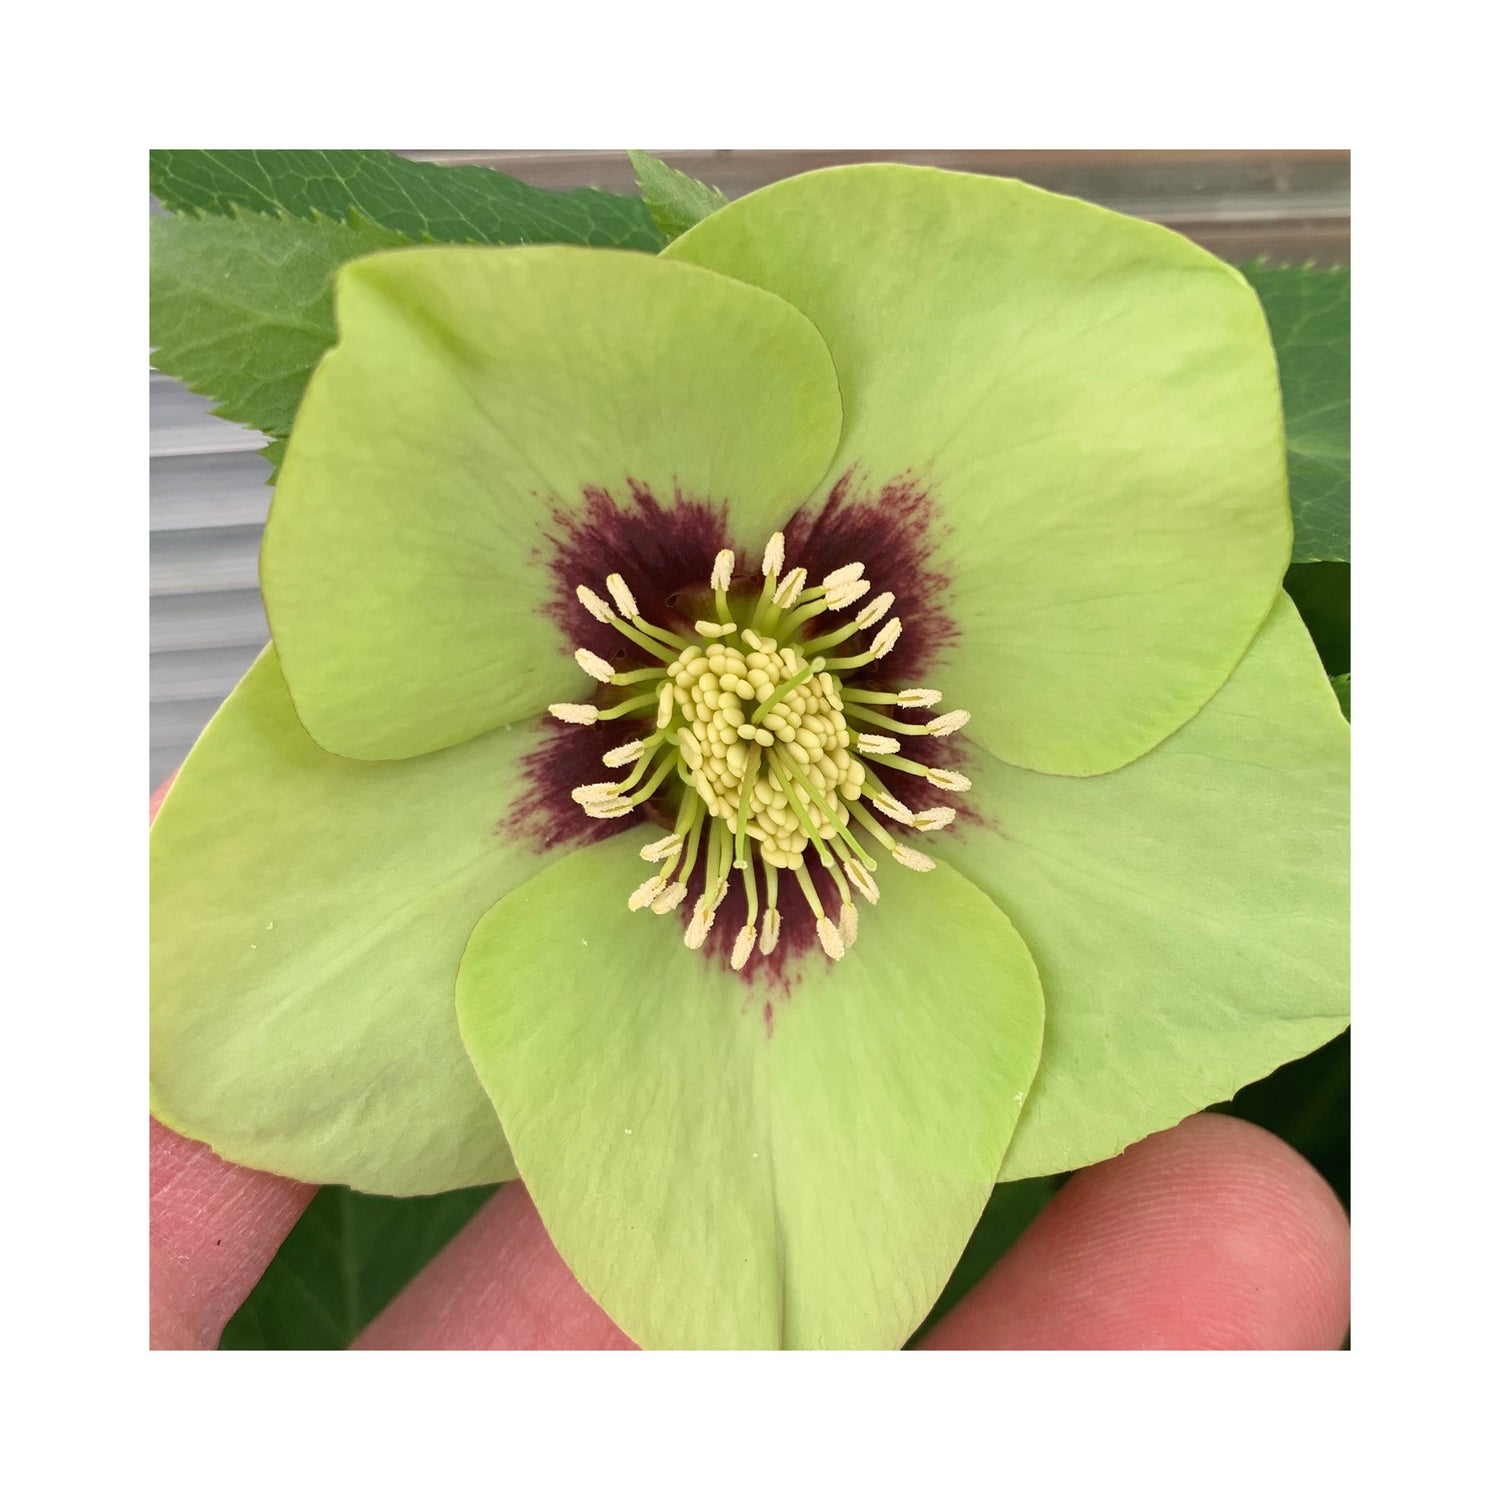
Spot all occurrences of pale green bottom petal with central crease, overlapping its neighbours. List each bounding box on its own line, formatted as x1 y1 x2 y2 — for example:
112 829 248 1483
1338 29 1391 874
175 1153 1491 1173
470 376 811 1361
459 839 1043 1349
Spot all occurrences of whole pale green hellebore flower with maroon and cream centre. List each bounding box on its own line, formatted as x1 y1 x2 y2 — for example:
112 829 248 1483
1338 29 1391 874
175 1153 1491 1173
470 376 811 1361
153 167 1347 1347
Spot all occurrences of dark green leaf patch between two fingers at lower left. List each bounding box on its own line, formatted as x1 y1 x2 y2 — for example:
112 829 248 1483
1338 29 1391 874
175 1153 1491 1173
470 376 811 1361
219 1188 494 1349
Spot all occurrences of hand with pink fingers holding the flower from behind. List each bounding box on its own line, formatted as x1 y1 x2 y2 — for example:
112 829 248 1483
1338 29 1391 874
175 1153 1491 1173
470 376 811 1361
150 783 1349 1349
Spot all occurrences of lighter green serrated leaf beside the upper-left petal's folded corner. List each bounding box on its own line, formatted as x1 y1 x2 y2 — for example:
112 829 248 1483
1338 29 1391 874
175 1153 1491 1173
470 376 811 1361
152 212 411 438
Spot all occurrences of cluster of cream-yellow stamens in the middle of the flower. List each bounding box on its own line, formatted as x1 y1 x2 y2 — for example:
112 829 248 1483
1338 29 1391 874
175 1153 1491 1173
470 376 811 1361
552 533 969 969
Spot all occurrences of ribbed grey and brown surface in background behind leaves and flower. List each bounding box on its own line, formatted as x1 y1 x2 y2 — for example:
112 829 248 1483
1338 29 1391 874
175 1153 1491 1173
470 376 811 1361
152 150 1349 786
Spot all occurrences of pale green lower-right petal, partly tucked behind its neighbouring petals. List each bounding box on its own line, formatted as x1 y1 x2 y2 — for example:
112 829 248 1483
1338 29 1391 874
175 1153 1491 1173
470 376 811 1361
945 596 1349 1179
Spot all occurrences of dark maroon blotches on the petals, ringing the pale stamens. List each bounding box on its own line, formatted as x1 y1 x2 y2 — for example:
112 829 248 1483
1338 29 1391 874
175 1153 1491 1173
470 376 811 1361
497 465 972 984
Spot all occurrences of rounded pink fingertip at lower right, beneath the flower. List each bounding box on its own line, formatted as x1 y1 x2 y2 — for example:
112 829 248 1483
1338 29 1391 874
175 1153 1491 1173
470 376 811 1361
924 1115 1349 1349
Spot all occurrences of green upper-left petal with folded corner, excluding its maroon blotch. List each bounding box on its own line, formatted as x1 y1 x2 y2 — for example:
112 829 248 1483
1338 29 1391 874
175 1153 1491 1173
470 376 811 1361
261 246 840 759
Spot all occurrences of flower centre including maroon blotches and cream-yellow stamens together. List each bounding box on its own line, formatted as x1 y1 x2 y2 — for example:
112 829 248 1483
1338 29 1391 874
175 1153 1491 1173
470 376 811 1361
510 470 968 996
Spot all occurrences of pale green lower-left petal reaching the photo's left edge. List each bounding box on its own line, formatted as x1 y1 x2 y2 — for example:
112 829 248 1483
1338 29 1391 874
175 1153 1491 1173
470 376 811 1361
152 651 570 1194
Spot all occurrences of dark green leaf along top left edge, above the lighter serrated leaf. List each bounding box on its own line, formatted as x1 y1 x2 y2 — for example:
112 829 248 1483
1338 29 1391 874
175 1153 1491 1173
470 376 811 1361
152 152 662 251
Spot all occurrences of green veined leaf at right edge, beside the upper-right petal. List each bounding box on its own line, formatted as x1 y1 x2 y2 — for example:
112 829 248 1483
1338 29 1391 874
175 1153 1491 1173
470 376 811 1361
1244 264 1349 563
